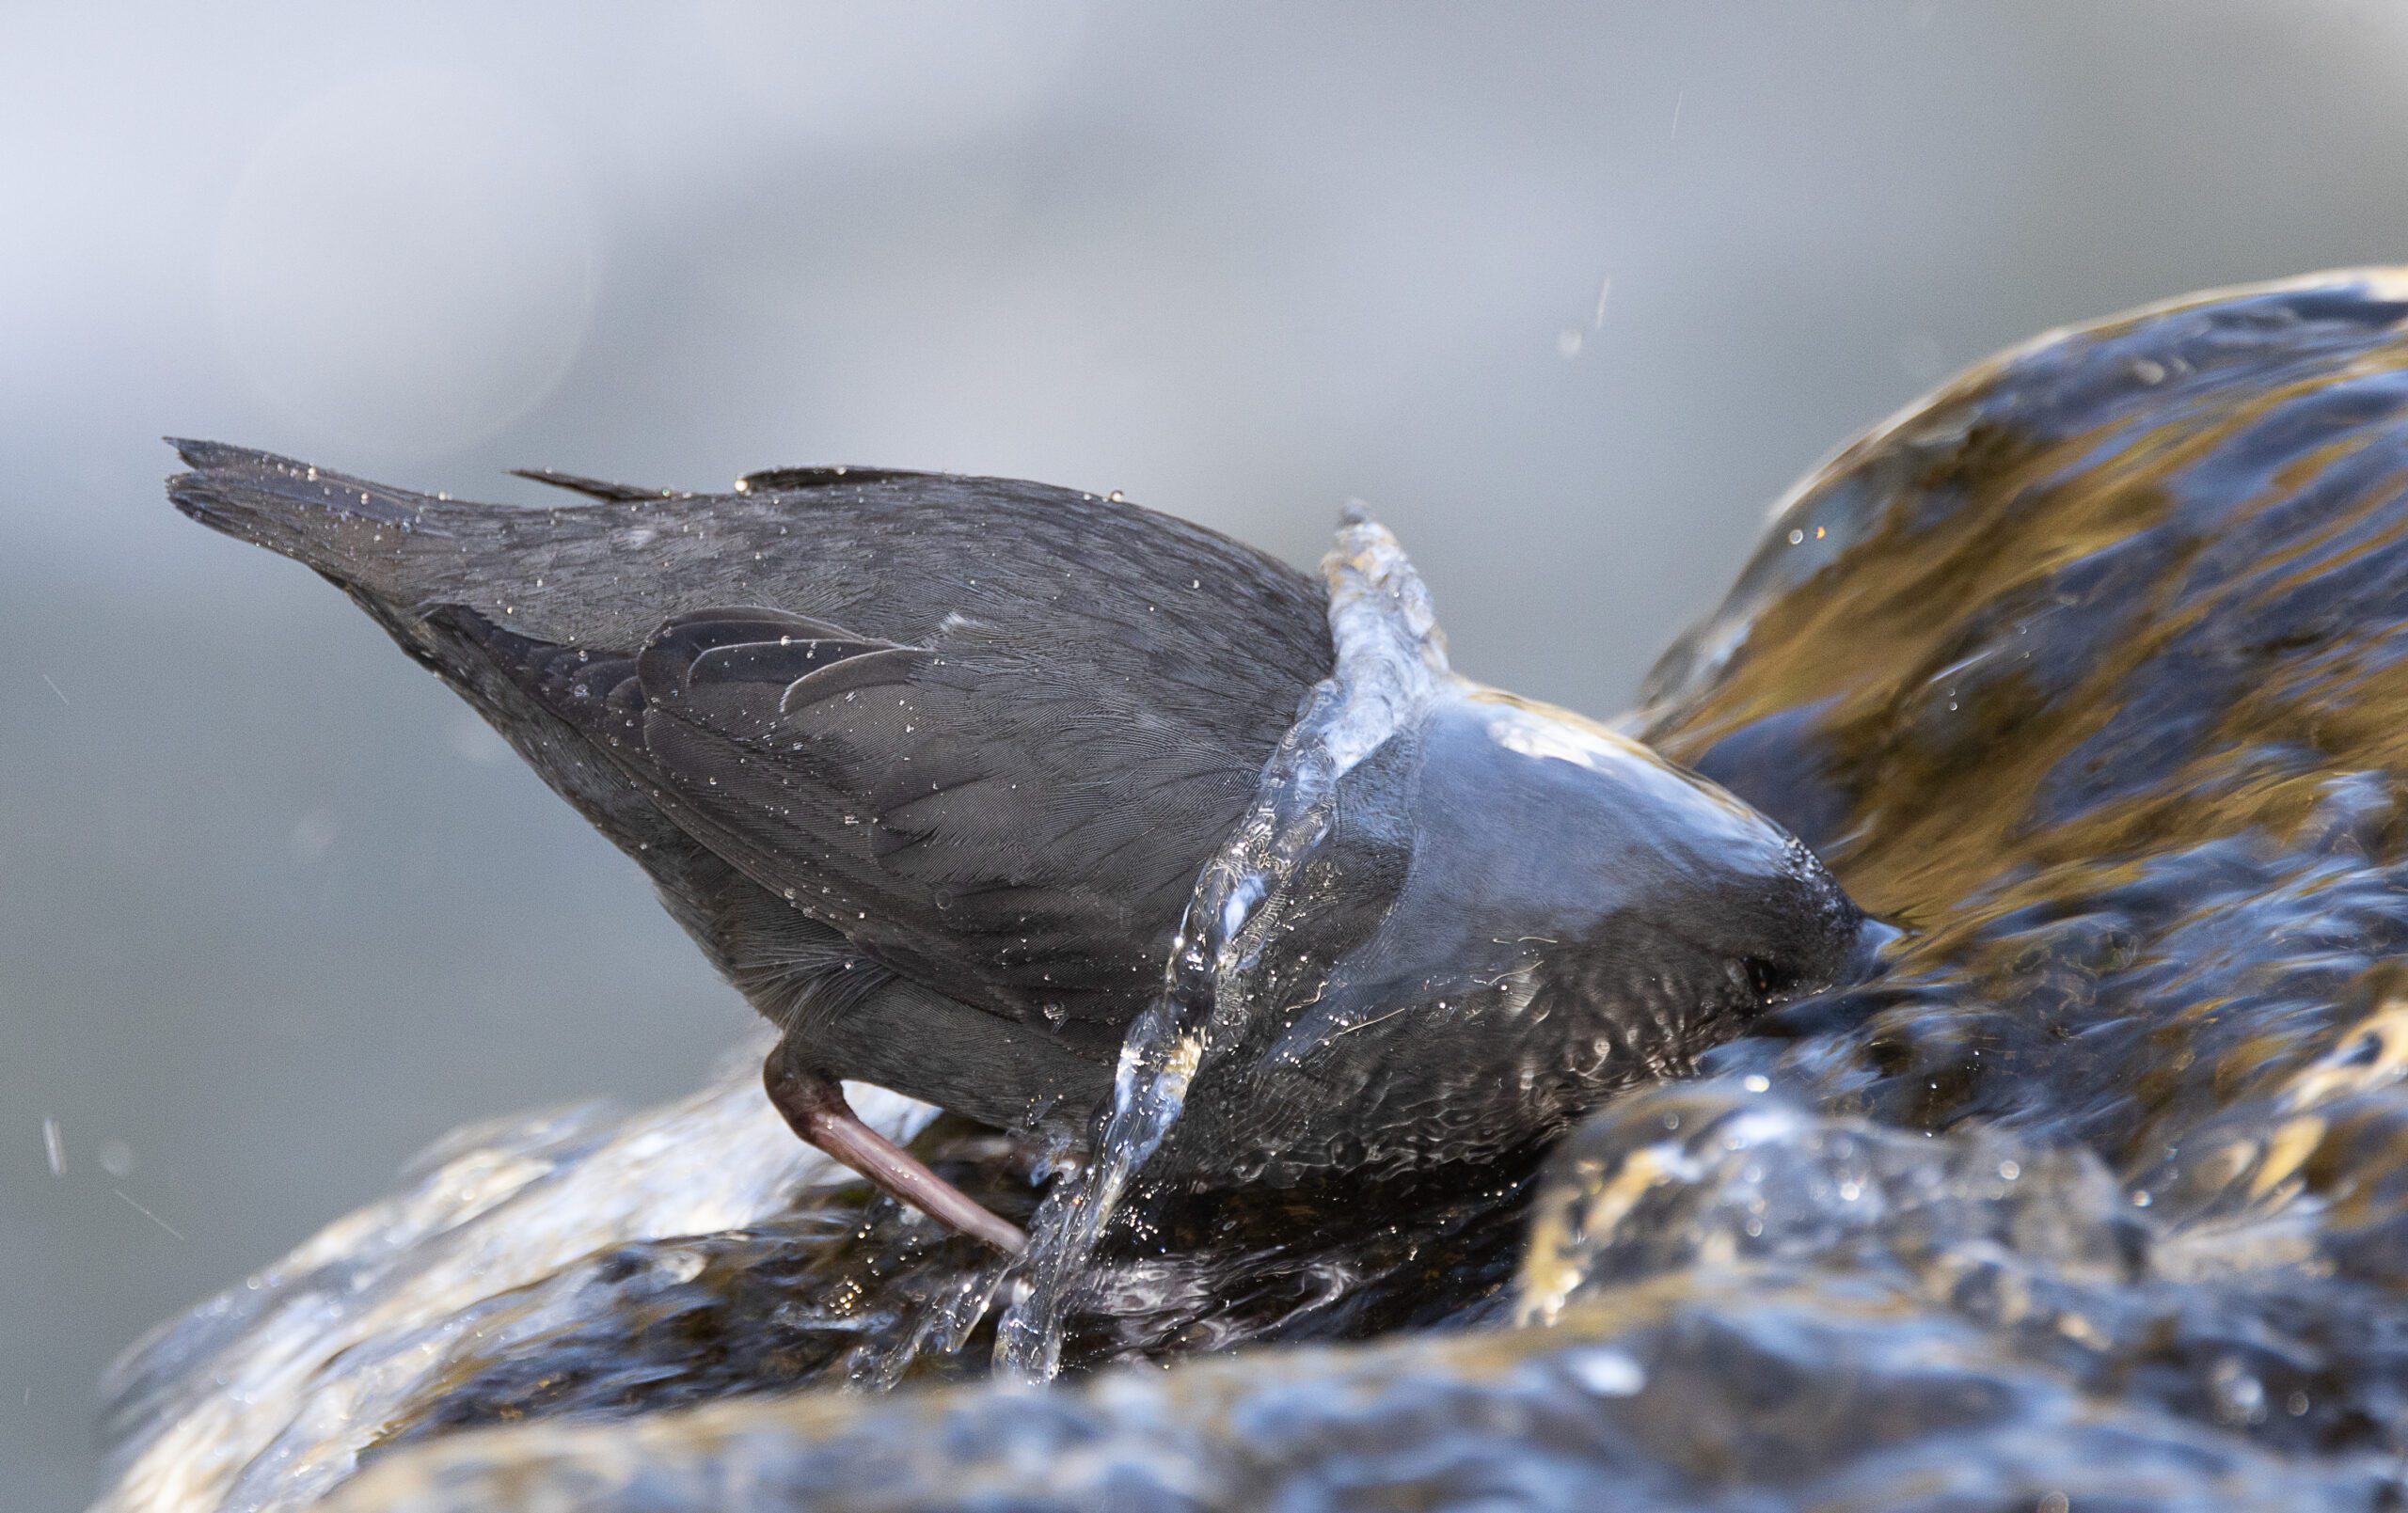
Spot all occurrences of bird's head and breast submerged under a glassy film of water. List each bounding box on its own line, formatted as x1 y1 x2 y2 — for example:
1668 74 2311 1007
1165 678 1895 1184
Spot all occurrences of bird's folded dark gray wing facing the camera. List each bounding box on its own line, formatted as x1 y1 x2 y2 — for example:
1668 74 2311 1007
451 584 1317 1032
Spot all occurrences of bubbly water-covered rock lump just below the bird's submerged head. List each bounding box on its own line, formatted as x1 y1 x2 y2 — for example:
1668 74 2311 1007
1519 1085 2408 1456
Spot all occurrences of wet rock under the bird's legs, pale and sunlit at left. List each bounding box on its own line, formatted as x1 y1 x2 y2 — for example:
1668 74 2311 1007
96 1051 1529 1513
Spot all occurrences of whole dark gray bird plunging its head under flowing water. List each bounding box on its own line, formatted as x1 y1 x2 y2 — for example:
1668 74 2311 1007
168 443 1891 1249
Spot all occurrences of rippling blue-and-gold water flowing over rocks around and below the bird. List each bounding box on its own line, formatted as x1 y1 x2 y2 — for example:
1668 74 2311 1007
103 275 2408 1513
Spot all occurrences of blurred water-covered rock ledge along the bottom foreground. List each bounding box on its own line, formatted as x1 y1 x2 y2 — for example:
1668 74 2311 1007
330 1287 2396 1513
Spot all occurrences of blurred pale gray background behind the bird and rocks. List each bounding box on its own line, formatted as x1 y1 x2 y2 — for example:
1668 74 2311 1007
0 0 2408 1510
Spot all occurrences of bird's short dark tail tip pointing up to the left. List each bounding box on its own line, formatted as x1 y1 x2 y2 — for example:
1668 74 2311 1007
166 438 477 599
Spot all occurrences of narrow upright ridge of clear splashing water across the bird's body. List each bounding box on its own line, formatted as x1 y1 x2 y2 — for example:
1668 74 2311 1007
994 508 1452 1380
